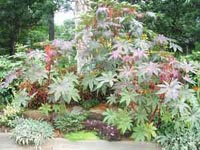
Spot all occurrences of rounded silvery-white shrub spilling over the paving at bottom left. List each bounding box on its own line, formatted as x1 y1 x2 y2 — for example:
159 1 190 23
11 119 53 148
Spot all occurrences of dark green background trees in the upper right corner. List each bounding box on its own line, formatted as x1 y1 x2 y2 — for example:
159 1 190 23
142 0 200 53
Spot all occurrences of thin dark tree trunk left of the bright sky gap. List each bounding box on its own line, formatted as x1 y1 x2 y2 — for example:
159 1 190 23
48 11 55 41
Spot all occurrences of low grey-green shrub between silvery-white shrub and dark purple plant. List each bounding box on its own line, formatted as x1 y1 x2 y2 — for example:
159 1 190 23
54 113 86 133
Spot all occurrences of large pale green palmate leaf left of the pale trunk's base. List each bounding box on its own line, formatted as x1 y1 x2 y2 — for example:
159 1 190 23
49 73 80 103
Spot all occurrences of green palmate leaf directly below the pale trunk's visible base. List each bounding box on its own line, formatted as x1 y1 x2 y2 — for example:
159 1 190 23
82 73 97 91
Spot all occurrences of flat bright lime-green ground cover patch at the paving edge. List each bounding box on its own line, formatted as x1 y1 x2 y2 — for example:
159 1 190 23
64 131 99 141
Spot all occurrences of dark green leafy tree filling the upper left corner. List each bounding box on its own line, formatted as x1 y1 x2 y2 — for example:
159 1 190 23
0 0 45 55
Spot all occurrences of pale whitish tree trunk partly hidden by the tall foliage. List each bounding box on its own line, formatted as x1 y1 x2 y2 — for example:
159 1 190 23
74 0 90 73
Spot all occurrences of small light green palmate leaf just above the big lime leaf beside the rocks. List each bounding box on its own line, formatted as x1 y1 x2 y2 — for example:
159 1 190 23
120 89 139 106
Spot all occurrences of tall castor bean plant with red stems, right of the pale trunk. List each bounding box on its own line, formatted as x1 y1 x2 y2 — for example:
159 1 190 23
75 1 199 141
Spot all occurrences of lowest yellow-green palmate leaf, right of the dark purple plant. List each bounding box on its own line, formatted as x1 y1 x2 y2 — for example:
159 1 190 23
132 123 157 141
